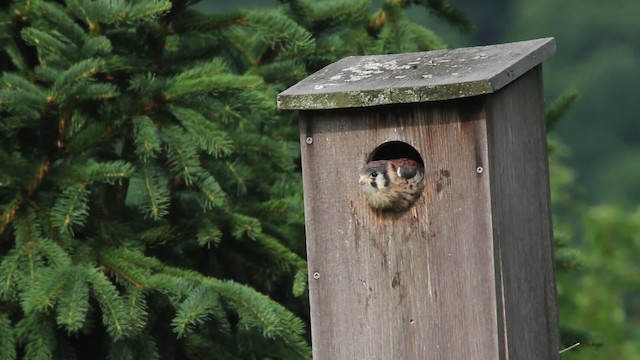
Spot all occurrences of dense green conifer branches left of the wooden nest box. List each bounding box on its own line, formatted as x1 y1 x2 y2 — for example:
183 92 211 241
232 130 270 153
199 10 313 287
0 0 468 359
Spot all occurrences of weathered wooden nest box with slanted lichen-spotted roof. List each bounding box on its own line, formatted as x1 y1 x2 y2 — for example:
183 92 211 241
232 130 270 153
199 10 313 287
278 38 559 360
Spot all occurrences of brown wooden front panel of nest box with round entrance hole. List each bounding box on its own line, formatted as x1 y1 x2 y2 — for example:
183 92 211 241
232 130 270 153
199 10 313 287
300 97 499 360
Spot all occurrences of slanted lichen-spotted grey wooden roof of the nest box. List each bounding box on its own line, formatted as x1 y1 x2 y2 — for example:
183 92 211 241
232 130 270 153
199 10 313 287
277 38 556 110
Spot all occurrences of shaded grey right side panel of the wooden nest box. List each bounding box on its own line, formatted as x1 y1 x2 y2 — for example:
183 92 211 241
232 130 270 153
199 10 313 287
487 66 560 359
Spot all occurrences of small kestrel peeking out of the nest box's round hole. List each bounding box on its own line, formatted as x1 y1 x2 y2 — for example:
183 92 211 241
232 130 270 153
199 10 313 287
359 159 424 212
